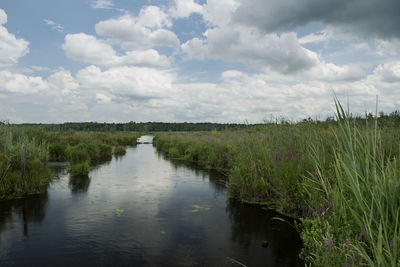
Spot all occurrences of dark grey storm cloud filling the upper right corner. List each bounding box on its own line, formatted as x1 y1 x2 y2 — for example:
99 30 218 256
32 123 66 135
232 0 400 39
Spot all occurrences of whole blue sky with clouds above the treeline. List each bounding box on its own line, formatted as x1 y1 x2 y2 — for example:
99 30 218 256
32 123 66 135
0 0 400 123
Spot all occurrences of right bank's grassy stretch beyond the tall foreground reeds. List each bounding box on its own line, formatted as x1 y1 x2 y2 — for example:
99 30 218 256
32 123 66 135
153 122 334 216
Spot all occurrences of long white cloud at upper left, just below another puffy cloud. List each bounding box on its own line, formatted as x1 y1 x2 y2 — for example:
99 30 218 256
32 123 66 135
62 33 170 68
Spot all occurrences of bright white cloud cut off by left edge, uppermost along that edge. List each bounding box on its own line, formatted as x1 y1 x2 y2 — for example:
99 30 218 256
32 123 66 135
0 9 29 67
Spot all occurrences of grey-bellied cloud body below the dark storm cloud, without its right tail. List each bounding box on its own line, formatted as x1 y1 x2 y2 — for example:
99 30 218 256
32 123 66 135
182 27 318 73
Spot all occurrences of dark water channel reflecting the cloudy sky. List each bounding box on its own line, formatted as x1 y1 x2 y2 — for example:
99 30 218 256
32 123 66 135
0 139 302 266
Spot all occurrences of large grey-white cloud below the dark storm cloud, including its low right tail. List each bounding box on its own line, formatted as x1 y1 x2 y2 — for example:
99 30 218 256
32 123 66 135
182 27 365 80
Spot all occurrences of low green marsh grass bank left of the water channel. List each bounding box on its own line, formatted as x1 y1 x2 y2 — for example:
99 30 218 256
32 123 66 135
0 129 140 199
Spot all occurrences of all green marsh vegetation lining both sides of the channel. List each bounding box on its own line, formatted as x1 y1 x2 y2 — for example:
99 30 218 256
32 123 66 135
0 103 400 266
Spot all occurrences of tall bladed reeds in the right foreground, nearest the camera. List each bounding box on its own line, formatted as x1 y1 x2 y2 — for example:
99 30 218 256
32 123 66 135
302 102 400 266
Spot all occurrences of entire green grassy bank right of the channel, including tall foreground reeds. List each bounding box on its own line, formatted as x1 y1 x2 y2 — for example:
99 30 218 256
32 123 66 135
154 106 400 266
